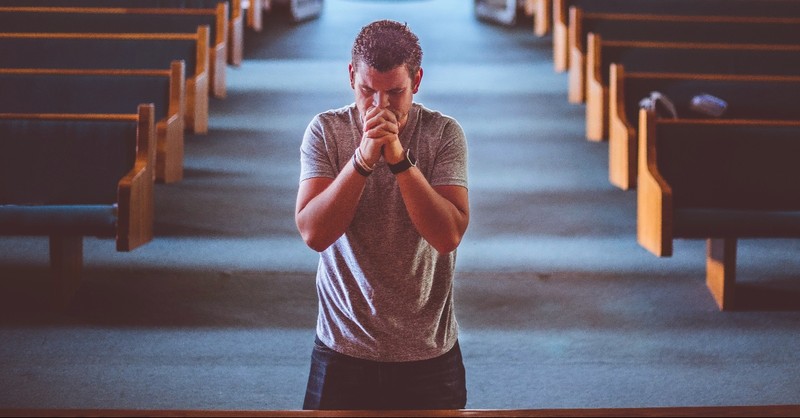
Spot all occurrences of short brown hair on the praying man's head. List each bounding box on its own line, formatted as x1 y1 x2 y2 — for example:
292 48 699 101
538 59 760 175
352 20 422 79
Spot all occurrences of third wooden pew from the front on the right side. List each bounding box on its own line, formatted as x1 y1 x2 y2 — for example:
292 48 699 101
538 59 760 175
586 33 800 141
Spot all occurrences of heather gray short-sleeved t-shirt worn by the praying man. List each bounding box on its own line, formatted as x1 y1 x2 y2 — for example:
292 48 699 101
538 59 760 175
300 103 467 361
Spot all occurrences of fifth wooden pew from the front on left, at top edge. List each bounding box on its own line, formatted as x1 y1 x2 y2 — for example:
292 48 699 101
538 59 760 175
0 0 244 65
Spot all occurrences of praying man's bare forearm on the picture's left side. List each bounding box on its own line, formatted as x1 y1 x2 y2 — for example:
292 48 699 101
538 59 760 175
294 163 367 251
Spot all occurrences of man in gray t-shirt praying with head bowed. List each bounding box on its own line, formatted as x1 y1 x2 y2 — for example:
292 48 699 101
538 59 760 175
295 20 469 409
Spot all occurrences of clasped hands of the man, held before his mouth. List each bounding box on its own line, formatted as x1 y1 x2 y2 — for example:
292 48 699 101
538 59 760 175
359 107 403 167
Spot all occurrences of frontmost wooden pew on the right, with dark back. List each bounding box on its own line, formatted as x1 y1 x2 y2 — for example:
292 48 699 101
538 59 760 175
636 110 800 310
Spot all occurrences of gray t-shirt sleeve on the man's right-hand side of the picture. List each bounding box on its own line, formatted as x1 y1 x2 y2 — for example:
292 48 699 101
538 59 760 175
430 119 467 187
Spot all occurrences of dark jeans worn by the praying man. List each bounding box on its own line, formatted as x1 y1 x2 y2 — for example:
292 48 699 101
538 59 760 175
303 339 467 410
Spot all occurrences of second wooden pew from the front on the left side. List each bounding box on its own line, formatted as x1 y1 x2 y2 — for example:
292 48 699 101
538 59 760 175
0 61 184 183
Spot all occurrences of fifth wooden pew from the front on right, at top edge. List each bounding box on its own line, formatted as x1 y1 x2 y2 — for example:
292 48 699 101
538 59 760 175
552 0 800 72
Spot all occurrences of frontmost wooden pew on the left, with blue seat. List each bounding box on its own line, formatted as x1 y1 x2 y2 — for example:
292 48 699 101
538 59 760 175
0 105 155 306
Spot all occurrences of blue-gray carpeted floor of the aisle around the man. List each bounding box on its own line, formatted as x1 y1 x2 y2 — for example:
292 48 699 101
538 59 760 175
0 0 800 410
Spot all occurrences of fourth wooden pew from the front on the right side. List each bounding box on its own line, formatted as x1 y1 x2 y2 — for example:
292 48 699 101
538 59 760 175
568 7 800 103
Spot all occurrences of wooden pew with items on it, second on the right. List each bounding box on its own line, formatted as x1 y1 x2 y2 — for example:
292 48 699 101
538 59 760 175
608 64 800 190
